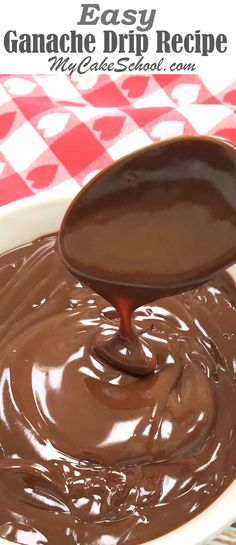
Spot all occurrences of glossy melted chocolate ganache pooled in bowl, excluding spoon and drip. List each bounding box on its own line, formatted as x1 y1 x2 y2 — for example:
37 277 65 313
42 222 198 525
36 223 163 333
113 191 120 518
0 236 236 545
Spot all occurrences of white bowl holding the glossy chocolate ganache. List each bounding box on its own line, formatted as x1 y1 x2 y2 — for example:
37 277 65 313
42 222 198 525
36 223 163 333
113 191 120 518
0 194 236 545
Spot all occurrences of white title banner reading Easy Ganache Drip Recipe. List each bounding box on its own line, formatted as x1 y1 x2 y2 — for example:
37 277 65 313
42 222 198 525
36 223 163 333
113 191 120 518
0 0 236 78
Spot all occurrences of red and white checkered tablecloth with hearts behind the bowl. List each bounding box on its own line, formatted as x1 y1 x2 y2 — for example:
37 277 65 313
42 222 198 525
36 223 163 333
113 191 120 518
0 74 236 545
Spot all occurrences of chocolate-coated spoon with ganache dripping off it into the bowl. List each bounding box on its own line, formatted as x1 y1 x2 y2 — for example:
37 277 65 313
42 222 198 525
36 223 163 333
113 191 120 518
59 136 236 373
